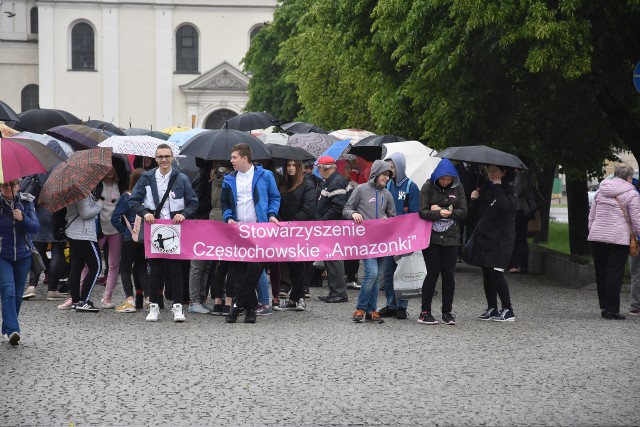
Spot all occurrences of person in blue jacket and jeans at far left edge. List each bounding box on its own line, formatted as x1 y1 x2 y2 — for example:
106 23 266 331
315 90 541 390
0 179 40 347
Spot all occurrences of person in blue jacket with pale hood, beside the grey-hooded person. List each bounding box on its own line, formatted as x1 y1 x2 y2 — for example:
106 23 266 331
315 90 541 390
379 153 420 319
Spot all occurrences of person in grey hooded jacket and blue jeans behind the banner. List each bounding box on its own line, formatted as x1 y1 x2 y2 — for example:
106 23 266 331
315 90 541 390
342 160 396 323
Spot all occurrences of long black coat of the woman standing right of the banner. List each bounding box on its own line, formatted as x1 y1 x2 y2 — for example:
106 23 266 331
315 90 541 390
471 182 517 269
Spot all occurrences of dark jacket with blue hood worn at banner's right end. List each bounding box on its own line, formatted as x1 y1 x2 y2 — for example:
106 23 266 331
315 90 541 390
419 159 467 246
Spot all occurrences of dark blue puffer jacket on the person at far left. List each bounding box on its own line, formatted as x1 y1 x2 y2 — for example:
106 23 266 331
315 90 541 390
0 193 40 261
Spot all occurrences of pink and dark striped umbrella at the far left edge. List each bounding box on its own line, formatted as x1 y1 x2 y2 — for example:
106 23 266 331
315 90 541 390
0 138 62 182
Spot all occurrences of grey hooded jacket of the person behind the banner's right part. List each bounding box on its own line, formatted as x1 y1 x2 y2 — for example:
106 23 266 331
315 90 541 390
342 160 396 219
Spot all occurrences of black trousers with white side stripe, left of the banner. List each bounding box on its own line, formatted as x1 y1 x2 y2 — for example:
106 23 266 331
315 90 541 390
68 239 102 303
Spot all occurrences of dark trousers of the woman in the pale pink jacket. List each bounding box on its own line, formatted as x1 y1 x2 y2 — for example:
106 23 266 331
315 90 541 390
591 242 629 313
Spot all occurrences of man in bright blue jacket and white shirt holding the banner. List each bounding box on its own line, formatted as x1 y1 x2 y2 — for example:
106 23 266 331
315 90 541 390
220 144 280 323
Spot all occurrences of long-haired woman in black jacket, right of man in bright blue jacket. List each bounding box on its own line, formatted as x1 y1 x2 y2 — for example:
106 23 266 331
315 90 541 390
274 160 316 311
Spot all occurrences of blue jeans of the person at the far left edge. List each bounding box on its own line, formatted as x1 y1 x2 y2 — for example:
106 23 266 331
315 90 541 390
0 256 31 335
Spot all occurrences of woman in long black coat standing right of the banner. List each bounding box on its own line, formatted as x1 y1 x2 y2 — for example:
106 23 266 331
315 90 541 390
471 165 517 322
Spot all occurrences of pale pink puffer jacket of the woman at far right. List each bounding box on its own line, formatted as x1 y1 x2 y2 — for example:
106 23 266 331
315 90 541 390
587 178 640 246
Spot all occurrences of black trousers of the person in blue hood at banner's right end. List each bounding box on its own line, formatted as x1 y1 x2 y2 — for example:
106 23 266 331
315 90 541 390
422 245 458 314
